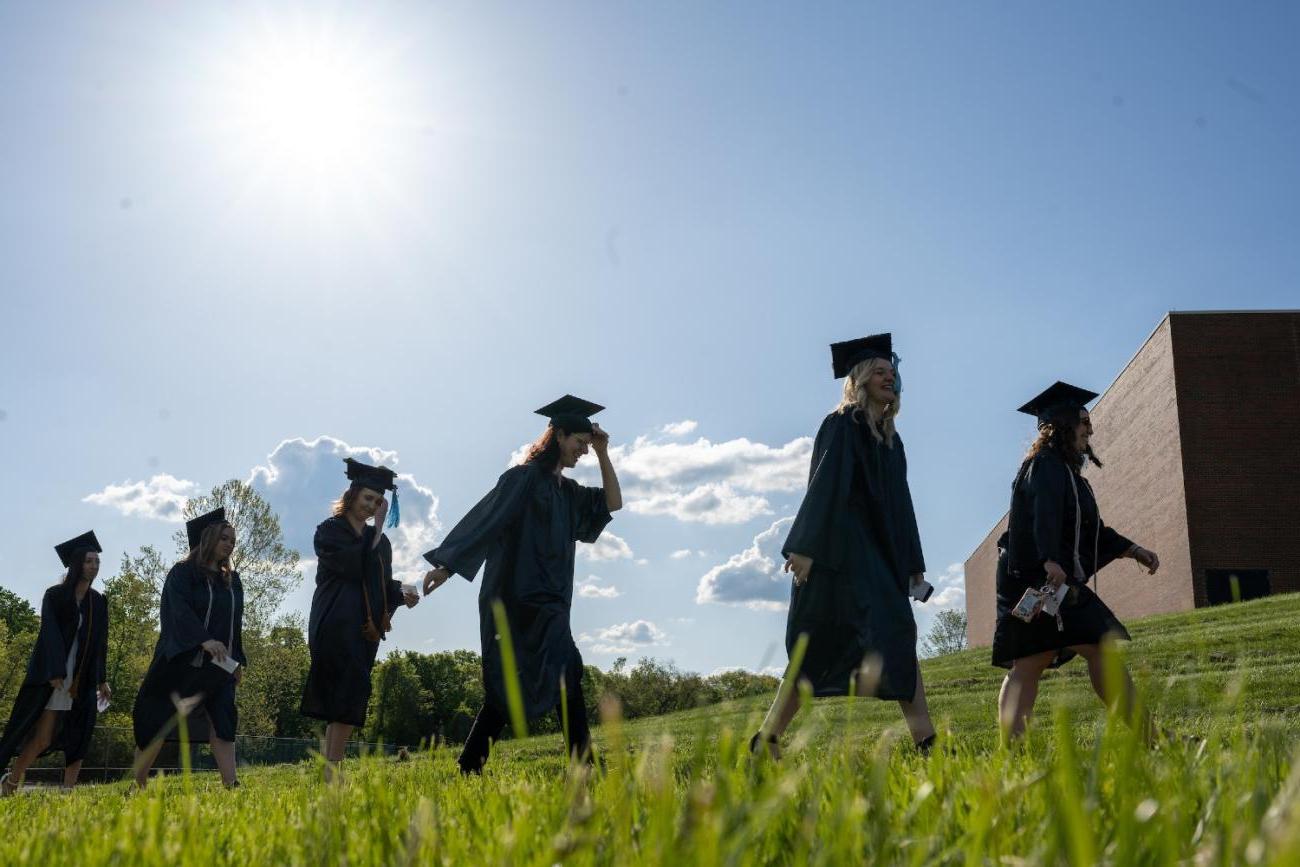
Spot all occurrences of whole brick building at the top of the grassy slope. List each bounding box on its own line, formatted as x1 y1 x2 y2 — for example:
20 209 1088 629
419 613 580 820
966 311 1300 646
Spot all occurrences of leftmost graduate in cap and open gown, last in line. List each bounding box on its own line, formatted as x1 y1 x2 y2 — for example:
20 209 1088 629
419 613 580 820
0 532 112 794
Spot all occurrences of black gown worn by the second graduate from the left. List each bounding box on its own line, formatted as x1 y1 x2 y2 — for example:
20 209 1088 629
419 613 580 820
131 562 248 749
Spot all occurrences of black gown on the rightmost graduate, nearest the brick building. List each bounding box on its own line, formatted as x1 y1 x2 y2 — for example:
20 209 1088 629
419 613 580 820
993 450 1132 668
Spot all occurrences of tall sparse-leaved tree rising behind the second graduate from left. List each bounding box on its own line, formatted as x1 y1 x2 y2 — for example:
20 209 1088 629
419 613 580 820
174 478 303 634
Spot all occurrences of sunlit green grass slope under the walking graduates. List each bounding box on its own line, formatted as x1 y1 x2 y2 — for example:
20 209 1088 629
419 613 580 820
0 595 1300 867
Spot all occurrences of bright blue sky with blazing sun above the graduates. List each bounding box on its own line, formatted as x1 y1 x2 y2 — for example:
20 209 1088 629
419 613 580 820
0 3 1300 672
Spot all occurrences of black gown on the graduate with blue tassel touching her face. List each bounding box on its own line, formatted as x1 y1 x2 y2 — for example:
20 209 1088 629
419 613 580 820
302 517 404 725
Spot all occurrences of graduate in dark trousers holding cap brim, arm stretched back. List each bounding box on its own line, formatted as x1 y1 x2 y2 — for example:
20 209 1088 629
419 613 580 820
424 395 623 773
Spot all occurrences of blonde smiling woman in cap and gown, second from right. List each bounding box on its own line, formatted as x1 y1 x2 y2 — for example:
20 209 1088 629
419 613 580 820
750 334 935 757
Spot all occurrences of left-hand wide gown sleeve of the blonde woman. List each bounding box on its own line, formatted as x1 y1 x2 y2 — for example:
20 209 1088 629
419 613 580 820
781 413 853 571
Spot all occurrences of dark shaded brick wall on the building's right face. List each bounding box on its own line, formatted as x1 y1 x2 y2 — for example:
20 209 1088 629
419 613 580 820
1170 311 1300 604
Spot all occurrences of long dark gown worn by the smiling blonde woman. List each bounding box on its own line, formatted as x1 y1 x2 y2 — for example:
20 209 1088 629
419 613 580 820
781 412 926 701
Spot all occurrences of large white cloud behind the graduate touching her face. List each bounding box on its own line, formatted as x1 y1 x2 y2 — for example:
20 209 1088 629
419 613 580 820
248 437 442 581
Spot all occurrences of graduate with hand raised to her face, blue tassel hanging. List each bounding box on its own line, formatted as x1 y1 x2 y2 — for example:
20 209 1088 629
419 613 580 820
302 458 420 777
